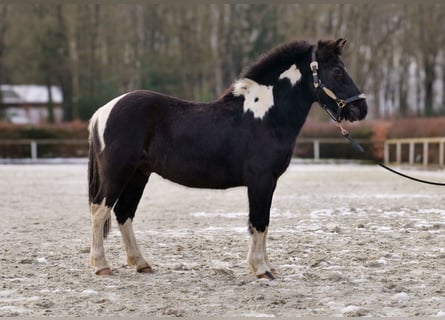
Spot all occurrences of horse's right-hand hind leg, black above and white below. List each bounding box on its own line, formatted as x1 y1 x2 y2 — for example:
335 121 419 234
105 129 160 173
114 171 153 273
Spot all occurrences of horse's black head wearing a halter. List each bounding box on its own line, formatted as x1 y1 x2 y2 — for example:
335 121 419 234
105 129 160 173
311 39 368 122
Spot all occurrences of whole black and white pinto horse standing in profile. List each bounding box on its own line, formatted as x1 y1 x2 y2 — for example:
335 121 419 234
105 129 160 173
89 39 367 279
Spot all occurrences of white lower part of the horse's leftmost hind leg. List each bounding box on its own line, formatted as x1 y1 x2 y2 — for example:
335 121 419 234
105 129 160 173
90 199 111 272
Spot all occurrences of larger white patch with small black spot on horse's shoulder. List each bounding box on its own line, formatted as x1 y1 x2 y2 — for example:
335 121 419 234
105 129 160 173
232 78 274 119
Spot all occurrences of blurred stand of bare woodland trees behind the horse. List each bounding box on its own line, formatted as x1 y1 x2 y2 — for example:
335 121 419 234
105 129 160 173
0 4 445 120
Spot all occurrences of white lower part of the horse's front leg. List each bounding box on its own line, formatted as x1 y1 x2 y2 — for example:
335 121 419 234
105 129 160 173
247 228 271 276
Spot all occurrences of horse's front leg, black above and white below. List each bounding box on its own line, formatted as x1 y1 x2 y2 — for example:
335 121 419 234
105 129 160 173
247 179 276 279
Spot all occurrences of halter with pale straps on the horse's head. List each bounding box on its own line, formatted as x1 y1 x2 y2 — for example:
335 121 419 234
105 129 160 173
310 49 366 122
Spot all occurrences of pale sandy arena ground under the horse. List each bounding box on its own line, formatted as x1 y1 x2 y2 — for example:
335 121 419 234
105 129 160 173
0 164 445 317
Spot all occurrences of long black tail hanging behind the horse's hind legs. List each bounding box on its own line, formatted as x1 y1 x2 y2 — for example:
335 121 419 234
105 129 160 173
88 124 111 238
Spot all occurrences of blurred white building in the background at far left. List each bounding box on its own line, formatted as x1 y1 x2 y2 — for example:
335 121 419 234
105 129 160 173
0 84 63 125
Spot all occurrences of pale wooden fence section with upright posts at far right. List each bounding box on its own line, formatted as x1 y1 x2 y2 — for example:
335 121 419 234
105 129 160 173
384 137 445 167
